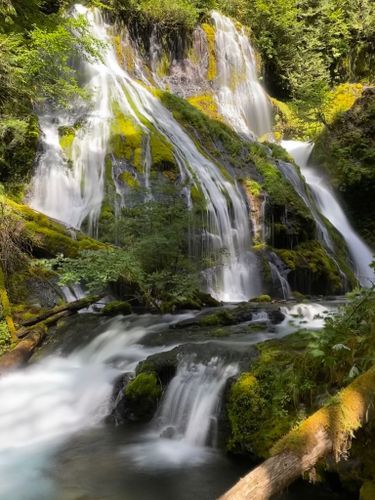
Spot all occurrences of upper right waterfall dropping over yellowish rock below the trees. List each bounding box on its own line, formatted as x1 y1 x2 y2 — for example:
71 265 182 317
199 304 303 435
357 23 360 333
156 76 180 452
212 12 272 137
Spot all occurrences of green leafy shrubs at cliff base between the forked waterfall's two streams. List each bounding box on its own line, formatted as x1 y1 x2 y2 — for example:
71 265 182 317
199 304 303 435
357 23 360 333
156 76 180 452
48 187 203 309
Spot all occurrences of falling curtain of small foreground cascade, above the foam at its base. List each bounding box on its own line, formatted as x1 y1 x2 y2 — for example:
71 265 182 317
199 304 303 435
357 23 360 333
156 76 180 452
156 357 238 446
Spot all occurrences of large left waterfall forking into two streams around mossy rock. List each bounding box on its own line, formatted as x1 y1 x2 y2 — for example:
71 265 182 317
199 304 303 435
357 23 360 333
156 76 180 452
30 6 261 302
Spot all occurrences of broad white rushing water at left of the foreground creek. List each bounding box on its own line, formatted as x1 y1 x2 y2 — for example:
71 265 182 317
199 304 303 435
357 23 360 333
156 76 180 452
0 315 191 500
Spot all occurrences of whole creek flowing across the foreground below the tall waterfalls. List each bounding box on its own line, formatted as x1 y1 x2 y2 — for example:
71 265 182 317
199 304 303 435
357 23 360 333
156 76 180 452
0 302 350 500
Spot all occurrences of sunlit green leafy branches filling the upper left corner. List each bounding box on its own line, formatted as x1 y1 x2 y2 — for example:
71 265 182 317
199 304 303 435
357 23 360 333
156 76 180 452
0 0 98 188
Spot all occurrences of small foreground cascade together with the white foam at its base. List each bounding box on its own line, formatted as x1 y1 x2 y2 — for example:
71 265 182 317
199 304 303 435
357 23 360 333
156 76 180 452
123 357 238 469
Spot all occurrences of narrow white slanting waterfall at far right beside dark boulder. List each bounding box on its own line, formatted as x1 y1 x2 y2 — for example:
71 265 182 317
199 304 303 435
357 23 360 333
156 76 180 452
282 141 375 286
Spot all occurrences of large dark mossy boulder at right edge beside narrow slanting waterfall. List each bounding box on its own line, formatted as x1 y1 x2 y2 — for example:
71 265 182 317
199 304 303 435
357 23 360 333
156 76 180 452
313 89 375 249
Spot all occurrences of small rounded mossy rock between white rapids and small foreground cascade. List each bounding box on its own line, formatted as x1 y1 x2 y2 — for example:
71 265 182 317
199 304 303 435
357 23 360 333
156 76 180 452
124 372 162 422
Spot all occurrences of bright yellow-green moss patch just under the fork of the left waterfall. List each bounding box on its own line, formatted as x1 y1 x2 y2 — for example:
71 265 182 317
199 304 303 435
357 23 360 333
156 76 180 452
109 104 143 171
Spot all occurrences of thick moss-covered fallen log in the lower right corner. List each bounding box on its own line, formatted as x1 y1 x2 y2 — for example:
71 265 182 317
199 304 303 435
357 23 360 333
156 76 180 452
220 367 375 500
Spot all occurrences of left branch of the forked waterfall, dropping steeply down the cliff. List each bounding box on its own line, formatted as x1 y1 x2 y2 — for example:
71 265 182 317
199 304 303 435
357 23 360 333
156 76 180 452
29 6 112 235
